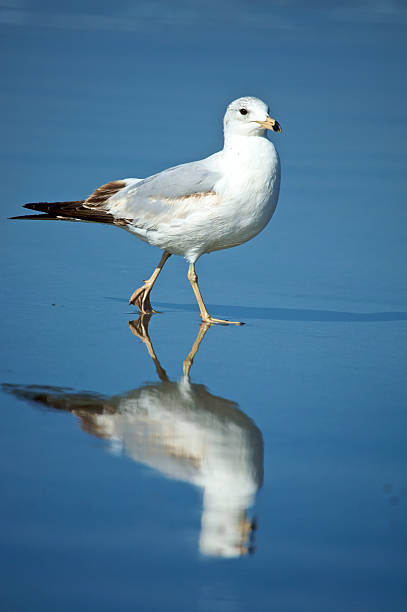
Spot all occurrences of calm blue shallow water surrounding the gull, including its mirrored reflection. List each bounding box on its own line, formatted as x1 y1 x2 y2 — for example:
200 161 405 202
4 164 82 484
0 2 407 612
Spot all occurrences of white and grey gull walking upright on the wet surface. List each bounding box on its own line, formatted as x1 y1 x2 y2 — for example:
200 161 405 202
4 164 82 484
12 96 282 325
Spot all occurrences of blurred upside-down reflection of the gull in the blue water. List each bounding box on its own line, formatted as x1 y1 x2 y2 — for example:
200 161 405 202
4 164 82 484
5 315 263 557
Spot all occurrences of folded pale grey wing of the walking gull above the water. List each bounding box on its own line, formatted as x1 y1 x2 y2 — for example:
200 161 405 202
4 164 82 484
106 154 222 229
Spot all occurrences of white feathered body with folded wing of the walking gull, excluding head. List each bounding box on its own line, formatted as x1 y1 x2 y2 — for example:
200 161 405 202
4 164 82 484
106 135 280 262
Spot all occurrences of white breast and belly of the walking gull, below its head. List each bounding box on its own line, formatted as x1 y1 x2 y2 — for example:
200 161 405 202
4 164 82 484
126 136 280 262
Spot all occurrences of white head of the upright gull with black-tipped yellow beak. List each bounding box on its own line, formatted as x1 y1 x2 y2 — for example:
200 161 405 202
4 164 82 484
223 96 282 137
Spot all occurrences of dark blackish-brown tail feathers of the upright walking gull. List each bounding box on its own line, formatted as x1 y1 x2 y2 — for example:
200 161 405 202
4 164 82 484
10 200 123 225
